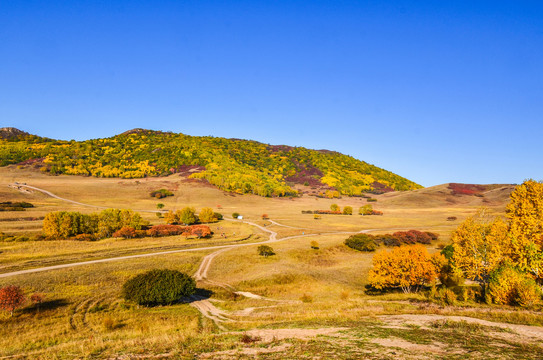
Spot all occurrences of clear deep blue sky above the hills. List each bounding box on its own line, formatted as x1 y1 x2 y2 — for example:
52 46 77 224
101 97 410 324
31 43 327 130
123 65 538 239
0 0 543 186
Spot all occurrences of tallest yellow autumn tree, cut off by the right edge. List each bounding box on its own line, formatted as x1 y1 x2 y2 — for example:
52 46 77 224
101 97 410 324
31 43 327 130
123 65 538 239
506 180 543 280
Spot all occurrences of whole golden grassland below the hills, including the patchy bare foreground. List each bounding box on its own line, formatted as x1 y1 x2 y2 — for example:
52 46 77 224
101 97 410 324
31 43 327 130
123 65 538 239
0 167 543 359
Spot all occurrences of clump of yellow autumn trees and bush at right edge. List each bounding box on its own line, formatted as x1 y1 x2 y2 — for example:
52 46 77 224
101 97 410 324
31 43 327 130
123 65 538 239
450 180 543 306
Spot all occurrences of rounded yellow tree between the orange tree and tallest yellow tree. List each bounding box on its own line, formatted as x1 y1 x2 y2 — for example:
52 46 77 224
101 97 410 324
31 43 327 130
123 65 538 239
451 208 511 288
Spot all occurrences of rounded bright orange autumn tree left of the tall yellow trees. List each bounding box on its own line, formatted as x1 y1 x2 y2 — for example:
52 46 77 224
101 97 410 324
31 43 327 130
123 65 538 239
368 244 444 293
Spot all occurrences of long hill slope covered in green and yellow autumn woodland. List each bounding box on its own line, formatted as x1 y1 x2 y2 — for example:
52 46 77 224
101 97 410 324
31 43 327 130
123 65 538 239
0 129 421 197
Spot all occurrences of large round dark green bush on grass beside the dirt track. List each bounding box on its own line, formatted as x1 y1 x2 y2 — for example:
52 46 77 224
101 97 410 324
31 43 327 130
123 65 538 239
122 269 196 306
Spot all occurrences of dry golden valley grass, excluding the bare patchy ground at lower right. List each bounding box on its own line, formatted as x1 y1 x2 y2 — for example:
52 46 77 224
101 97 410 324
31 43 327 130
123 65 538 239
0 167 543 359
